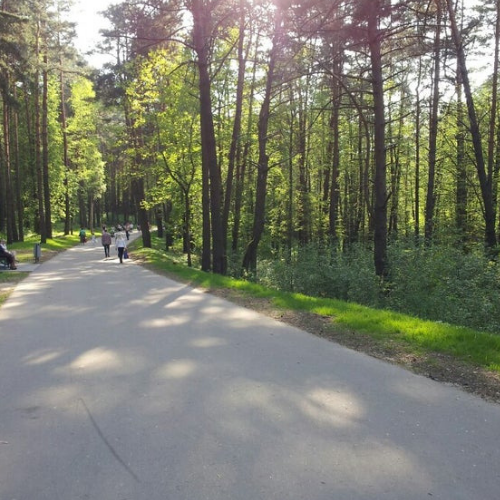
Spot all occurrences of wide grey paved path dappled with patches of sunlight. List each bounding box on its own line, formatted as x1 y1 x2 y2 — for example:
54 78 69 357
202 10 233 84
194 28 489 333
0 239 500 500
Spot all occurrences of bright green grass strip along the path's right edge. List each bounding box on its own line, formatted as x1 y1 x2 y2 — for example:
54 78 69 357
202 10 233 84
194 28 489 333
127 241 500 374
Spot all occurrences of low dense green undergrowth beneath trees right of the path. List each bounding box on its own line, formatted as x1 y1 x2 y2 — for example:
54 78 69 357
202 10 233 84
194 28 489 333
252 240 500 333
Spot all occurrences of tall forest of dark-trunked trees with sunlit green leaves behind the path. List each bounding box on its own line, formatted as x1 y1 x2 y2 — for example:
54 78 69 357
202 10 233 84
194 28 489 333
0 0 500 333
